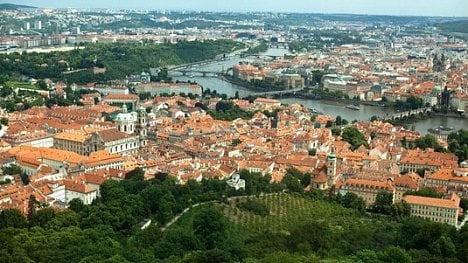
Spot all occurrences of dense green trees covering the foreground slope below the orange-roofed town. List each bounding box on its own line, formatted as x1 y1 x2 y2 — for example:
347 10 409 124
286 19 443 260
0 169 468 262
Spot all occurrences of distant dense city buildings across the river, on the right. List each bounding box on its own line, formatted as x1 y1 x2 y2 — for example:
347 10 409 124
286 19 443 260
233 28 468 114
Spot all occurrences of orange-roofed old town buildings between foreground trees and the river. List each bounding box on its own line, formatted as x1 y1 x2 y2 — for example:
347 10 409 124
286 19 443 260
0 94 468 225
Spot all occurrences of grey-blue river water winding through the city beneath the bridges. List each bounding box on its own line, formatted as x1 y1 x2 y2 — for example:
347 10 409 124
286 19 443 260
171 48 468 134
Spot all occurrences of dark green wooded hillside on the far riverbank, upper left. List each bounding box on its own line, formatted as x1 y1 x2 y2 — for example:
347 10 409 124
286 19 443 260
0 40 243 83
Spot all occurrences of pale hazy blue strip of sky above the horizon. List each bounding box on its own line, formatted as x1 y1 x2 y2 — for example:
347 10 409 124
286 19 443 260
5 0 468 17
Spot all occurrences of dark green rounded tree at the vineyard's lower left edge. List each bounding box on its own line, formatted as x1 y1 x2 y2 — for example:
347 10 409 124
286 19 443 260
193 206 227 249
